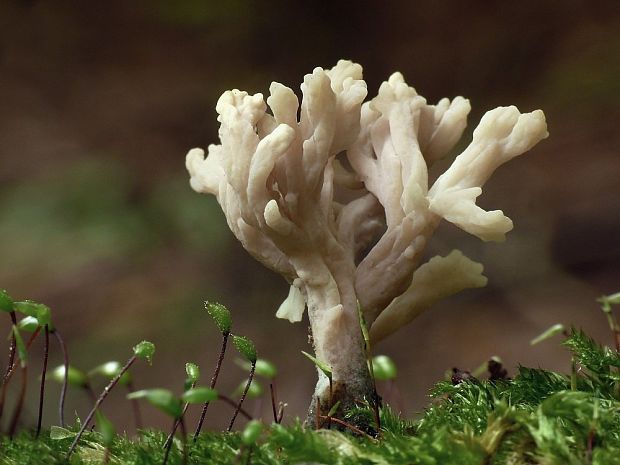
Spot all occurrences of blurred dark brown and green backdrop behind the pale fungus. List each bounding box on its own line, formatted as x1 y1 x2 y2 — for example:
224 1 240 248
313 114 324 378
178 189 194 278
0 0 620 429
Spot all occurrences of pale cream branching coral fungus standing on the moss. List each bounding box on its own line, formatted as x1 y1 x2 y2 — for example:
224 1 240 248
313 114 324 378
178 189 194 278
186 60 548 423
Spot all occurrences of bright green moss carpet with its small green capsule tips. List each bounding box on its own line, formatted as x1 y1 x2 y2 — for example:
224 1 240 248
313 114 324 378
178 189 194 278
0 290 620 465
